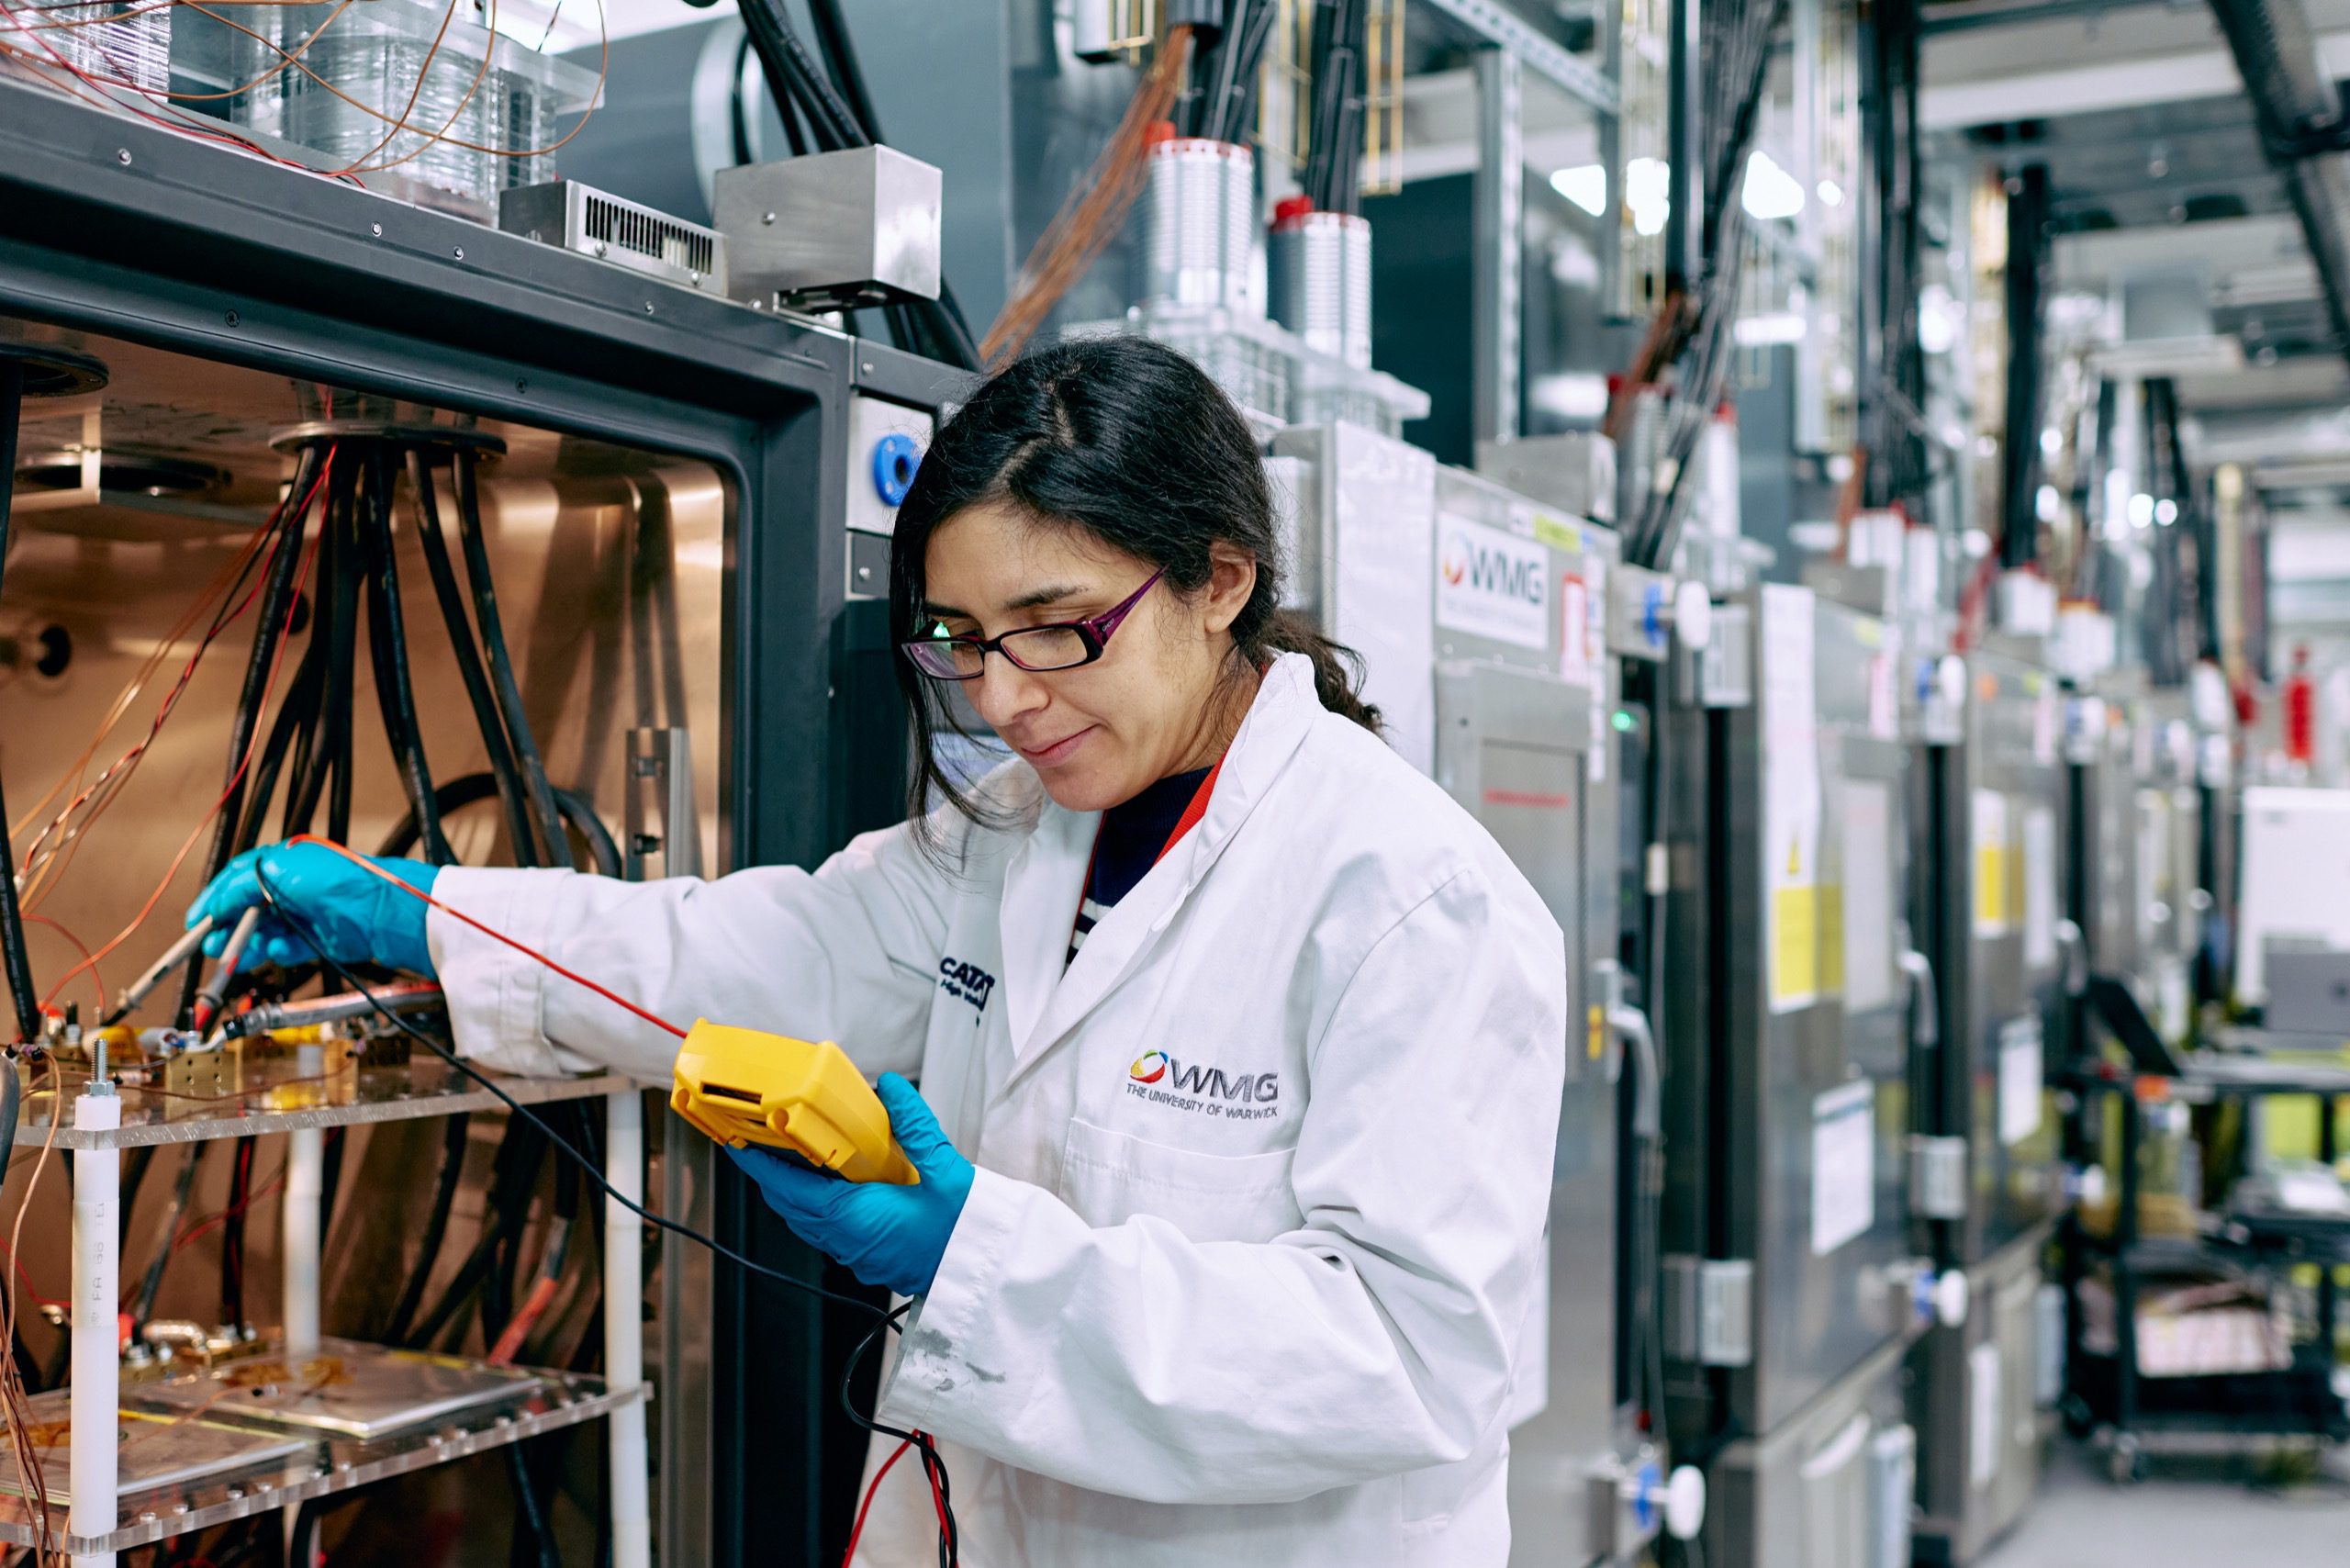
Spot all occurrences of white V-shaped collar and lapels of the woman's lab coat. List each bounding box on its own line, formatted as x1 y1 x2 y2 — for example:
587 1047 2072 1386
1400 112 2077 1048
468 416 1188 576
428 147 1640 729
1002 654 1323 1089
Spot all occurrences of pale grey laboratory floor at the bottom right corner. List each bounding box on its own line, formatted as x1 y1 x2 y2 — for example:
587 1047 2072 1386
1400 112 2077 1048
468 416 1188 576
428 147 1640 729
1979 1441 2350 1568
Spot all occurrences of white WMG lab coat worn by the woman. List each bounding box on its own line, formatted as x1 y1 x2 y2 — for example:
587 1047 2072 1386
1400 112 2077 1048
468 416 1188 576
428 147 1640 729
430 655 1568 1568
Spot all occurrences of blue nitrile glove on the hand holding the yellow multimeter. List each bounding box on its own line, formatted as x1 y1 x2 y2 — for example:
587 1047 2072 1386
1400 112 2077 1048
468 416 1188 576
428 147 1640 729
726 1072 970 1295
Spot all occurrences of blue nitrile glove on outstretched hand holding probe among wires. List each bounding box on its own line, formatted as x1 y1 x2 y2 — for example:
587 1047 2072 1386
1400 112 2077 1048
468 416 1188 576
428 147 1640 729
185 844 440 976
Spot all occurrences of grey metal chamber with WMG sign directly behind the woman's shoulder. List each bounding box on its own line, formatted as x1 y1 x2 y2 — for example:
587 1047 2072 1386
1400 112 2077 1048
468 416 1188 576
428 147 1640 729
1431 468 1638 1563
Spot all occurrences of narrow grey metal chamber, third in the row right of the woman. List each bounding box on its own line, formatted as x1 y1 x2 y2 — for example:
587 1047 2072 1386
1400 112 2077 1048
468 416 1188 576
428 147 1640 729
1910 651 2058 1563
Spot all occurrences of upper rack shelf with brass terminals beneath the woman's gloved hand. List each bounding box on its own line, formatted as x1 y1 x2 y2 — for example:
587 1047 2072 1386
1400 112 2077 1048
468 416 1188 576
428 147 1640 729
17 1058 632 1149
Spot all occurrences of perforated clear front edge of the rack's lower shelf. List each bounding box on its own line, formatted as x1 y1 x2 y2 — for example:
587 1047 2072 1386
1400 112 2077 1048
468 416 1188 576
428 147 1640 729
0 1372 651 1556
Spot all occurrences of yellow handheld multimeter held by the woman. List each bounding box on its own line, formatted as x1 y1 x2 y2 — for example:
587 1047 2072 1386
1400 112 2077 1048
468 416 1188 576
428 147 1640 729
670 1018 916 1187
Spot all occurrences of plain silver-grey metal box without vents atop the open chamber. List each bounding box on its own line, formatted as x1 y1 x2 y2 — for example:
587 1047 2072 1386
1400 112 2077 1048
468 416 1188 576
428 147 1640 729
710 146 940 306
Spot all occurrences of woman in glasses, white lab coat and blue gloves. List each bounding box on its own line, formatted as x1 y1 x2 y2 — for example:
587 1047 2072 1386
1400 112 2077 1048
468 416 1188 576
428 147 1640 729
190 339 1565 1568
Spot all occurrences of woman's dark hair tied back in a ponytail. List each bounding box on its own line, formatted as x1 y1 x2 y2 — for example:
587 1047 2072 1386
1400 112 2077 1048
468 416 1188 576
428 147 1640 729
889 339 1380 841
